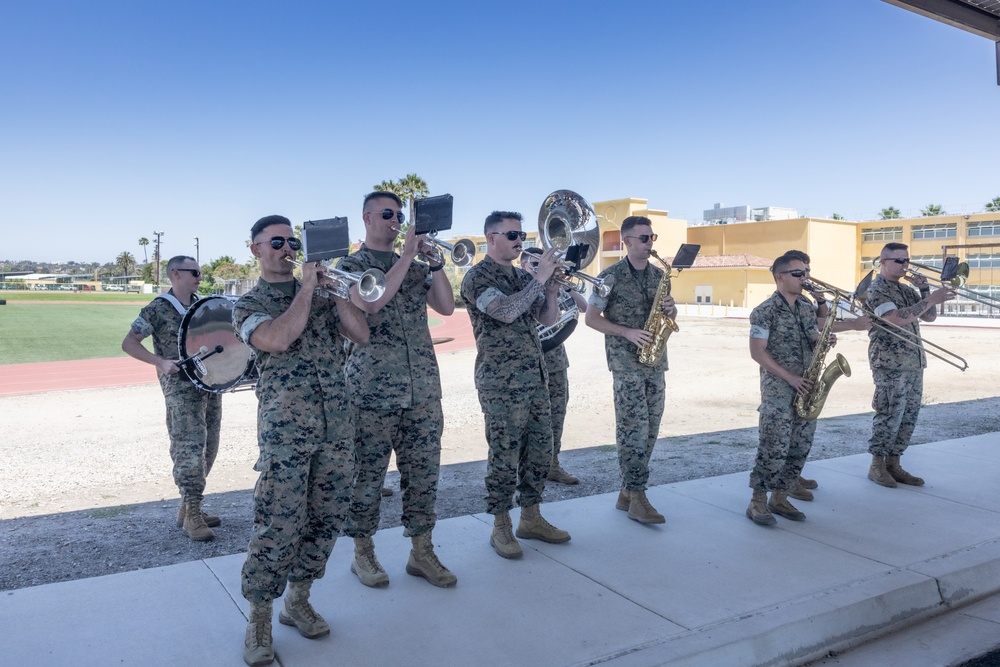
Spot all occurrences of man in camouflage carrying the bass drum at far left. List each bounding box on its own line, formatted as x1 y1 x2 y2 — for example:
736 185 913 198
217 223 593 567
122 256 222 541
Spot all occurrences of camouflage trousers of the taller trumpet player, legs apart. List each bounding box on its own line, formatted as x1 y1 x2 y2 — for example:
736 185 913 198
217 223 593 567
344 401 444 537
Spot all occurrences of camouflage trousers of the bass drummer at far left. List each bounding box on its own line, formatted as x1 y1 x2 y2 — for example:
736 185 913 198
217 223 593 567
164 383 222 500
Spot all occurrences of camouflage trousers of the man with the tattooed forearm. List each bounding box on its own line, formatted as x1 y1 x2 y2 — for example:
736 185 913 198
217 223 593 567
479 384 552 514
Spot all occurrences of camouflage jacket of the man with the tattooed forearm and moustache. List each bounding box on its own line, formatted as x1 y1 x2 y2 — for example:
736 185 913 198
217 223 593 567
462 255 548 392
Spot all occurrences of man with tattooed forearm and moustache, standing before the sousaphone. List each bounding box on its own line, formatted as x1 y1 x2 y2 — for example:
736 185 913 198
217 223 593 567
462 211 570 558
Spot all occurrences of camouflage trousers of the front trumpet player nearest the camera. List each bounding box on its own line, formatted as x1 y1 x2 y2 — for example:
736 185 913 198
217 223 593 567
241 440 354 602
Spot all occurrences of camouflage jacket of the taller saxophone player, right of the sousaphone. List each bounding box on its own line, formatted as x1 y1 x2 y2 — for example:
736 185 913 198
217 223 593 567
589 257 668 373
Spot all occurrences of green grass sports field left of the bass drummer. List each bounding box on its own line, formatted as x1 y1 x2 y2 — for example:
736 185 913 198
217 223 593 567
0 302 143 364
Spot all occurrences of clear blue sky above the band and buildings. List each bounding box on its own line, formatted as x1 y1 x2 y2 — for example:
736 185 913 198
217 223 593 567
0 0 1000 262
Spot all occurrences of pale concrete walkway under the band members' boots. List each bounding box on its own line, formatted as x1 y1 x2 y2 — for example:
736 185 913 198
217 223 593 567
0 434 1000 667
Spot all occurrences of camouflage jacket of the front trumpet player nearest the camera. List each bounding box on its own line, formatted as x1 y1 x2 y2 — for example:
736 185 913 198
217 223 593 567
233 280 354 446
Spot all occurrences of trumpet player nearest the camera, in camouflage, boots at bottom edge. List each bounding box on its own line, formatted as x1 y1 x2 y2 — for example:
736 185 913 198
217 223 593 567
233 216 368 665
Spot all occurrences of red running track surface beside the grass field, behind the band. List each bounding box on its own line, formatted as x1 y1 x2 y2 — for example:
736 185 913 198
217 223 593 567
0 310 476 396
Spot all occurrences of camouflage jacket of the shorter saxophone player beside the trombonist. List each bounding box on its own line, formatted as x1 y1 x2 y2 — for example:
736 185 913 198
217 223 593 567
750 291 819 400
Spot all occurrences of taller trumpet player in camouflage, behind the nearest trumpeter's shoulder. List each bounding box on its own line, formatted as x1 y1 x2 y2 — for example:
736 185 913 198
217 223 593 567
339 191 457 587
